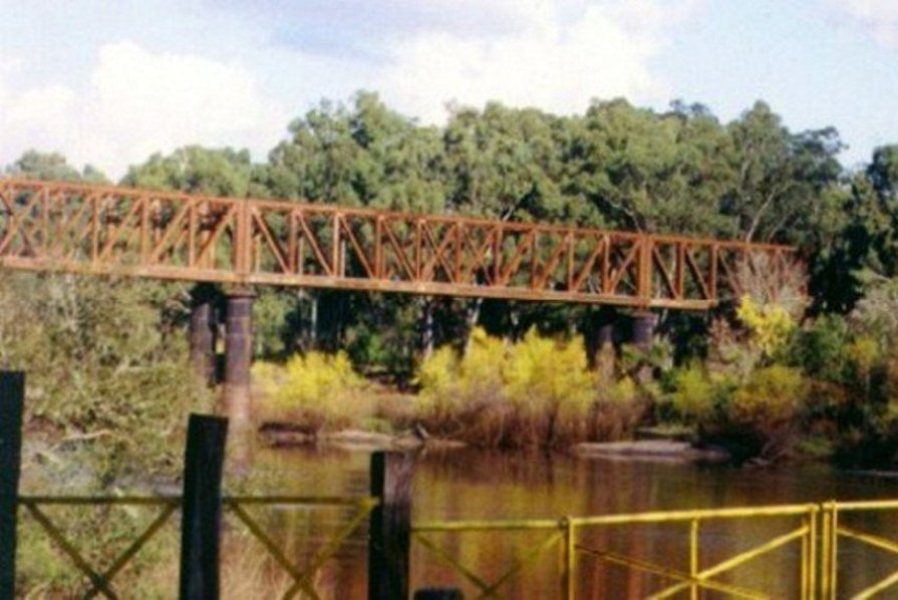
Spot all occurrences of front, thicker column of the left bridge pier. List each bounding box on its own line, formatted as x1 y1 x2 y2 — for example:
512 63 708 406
223 289 255 430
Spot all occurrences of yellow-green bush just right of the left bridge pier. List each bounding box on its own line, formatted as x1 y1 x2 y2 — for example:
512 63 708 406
253 352 372 434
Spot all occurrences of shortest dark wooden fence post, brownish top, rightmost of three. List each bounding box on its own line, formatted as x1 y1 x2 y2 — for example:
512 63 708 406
368 452 415 600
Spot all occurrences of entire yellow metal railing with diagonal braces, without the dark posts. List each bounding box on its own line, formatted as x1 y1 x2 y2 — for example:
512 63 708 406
19 496 898 600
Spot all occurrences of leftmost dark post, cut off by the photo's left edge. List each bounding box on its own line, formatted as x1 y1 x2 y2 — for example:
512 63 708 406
0 371 25 598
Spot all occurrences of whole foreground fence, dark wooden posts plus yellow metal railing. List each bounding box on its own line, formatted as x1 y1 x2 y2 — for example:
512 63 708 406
0 372 898 600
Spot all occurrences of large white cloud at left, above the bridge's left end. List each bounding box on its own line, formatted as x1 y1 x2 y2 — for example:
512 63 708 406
0 41 287 177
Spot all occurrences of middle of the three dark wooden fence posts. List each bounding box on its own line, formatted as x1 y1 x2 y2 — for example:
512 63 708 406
180 415 228 600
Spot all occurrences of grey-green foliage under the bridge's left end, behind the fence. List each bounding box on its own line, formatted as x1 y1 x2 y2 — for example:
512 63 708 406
0 274 209 487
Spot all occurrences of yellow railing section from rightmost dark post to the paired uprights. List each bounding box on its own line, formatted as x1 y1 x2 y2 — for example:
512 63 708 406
413 504 820 600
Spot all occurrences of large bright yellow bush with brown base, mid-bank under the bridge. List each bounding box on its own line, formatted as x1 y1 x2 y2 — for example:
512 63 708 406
417 328 645 447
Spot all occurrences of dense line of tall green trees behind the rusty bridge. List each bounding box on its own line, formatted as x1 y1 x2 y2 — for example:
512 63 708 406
6 93 898 376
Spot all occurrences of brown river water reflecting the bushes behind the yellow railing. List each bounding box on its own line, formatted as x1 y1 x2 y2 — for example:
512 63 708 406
222 449 898 599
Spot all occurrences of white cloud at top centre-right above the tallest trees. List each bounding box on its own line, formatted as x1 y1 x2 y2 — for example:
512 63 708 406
375 0 695 122
